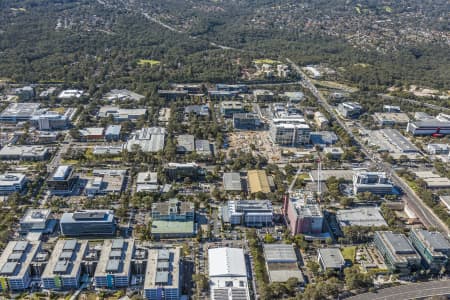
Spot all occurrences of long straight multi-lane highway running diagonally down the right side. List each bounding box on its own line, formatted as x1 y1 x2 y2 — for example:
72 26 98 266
286 58 450 234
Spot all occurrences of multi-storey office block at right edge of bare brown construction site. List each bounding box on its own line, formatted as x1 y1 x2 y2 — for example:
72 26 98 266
269 120 311 147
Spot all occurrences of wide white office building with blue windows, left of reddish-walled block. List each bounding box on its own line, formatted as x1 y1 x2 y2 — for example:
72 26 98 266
221 200 273 227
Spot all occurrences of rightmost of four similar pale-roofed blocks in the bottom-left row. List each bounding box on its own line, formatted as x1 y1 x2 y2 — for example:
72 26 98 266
144 248 181 300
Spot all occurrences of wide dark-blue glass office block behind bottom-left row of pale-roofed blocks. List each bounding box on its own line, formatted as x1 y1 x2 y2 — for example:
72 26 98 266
60 210 116 236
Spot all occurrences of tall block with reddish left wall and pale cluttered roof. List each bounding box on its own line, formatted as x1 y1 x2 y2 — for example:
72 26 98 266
283 193 323 235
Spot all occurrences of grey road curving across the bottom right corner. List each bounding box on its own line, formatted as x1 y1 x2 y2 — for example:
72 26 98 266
347 280 450 300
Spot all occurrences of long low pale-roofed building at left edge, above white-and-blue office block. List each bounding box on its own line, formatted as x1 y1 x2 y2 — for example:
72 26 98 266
0 145 50 161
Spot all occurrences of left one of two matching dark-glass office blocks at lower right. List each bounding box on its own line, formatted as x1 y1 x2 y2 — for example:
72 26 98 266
374 231 421 275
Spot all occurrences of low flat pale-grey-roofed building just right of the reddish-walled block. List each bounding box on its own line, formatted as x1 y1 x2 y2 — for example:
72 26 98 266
336 206 387 228
